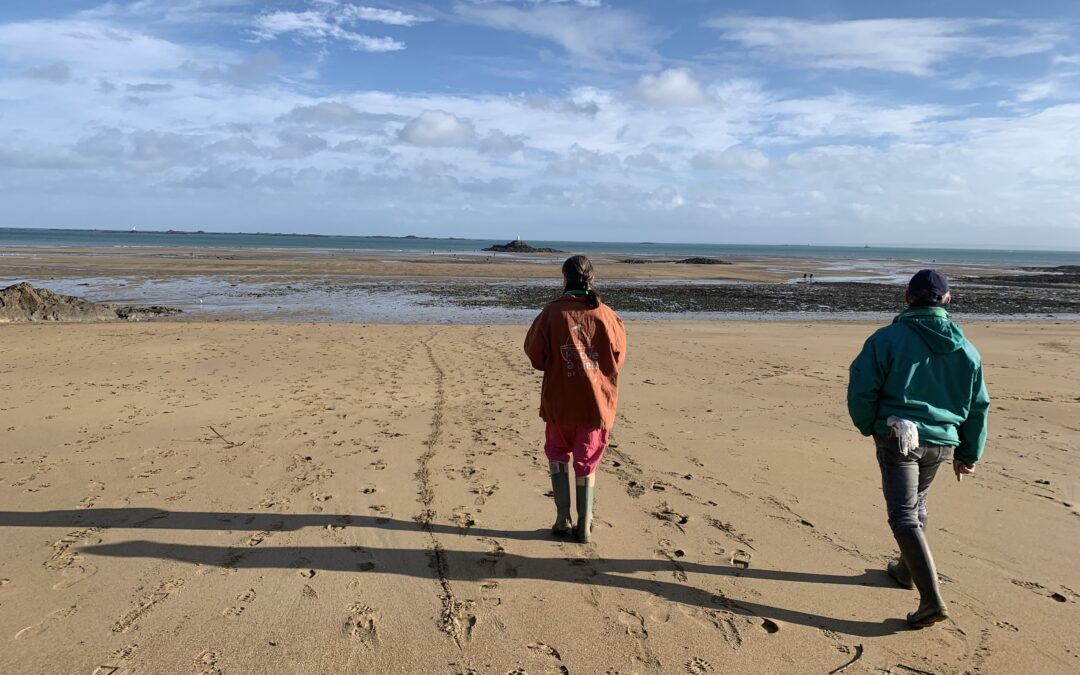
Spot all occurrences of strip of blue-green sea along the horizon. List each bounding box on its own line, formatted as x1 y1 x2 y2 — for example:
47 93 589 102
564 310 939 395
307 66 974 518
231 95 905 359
0 228 1080 271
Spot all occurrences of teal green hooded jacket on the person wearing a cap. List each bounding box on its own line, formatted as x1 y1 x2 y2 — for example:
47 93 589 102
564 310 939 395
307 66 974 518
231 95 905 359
848 307 990 464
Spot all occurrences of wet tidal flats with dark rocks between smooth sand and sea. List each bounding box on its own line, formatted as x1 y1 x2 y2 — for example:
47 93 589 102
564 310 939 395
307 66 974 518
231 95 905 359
0 248 1080 324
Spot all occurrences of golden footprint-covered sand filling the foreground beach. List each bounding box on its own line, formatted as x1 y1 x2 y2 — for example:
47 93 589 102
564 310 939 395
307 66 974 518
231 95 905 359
0 322 1080 675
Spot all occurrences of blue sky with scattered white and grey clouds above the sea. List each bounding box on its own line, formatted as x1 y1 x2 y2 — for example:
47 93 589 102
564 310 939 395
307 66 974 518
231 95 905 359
0 0 1080 248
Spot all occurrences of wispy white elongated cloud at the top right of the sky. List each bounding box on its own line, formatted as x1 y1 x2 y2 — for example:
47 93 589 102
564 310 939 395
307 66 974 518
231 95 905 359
707 17 1064 77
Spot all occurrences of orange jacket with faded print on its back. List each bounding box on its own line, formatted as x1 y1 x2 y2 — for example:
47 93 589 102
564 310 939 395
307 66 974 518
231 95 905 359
525 295 626 429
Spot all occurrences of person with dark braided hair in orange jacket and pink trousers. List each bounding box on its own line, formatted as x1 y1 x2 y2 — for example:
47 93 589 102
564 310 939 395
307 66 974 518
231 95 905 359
525 256 626 543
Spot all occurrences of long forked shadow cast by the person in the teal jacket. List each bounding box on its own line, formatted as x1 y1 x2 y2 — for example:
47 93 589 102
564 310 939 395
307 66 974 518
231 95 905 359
80 541 907 637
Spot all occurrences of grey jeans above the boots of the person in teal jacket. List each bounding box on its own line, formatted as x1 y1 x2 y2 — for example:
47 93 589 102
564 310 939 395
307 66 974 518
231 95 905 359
874 436 953 532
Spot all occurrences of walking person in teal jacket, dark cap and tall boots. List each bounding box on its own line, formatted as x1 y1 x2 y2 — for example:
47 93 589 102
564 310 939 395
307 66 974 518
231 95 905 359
848 270 990 627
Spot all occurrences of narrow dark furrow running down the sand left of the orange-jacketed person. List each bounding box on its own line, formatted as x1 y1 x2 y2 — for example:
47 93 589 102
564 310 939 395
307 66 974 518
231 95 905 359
414 336 476 649
